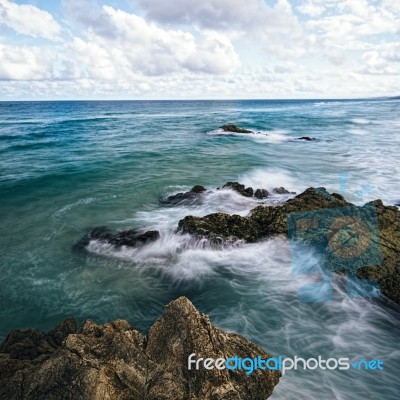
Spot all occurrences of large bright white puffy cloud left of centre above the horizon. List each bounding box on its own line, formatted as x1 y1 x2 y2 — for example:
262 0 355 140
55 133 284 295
67 6 240 79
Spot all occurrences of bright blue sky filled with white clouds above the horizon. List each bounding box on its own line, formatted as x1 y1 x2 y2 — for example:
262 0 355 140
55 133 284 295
0 0 400 100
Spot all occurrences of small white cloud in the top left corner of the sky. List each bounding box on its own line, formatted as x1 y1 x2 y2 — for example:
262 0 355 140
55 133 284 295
0 0 61 40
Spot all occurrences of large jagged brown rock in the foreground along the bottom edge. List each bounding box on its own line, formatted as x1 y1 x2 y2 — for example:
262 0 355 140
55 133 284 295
0 297 280 400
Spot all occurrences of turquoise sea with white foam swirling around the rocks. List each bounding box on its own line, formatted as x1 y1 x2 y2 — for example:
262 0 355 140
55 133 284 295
0 100 400 400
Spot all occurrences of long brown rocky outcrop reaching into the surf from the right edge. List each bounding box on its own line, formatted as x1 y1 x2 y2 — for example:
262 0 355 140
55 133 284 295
178 188 400 303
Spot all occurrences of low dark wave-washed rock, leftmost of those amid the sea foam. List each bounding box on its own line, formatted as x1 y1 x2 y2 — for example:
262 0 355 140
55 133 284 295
75 226 160 250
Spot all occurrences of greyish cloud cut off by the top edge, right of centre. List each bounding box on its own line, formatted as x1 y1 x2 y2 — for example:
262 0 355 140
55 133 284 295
138 0 301 50
